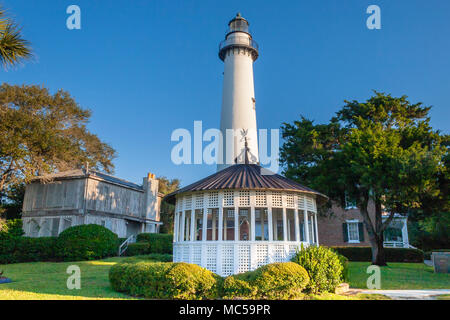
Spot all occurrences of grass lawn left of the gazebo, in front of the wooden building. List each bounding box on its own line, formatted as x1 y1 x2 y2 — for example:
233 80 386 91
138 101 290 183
0 256 162 300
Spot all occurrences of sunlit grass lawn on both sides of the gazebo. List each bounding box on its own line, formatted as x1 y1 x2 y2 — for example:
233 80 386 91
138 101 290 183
0 256 440 300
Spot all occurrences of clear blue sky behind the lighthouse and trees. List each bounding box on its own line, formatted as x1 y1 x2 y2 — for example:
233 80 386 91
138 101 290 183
0 0 450 185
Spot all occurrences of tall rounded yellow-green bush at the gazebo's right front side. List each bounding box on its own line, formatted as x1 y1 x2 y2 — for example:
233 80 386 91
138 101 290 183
291 246 344 294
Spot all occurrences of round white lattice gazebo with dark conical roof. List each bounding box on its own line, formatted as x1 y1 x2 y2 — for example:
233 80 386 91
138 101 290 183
166 164 325 276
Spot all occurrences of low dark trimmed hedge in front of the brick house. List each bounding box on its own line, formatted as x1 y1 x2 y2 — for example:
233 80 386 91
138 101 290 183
333 247 424 263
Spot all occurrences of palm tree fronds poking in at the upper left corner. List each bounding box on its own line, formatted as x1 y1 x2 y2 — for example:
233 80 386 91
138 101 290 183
0 7 31 69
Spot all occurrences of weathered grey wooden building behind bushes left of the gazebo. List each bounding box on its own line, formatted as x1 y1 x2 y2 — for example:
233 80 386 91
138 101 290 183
22 169 162 238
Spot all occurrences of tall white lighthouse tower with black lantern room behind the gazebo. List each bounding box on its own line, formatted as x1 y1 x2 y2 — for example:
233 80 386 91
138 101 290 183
217 13 259 171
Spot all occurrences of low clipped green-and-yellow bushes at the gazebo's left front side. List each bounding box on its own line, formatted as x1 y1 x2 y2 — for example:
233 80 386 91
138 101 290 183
109 262 219 300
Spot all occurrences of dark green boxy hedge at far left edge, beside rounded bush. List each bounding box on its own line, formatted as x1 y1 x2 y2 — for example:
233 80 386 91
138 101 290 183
0 237 56 264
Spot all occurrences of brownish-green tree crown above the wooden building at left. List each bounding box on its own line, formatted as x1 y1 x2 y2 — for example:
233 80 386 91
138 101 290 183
0 83 115 193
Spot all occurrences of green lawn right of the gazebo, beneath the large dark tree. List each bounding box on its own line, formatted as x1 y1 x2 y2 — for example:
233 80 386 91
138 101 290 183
349 262 450 290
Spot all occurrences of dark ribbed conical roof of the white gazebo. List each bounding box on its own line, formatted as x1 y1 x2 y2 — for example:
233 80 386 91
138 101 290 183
164 164 327 203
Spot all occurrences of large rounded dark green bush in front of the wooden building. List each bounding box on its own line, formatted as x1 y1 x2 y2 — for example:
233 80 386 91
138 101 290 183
56 224 118 261
